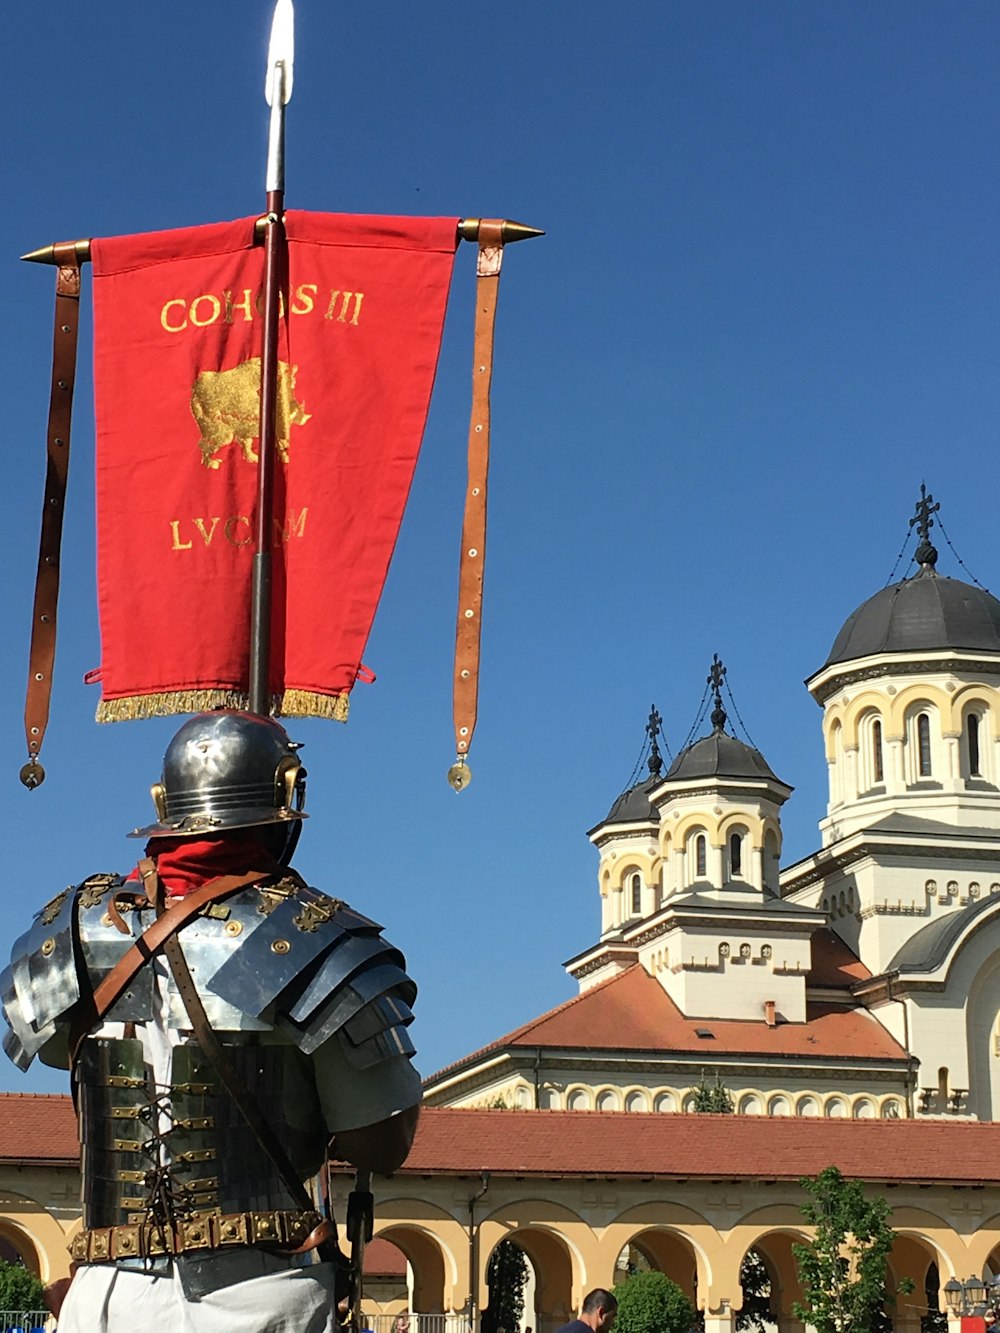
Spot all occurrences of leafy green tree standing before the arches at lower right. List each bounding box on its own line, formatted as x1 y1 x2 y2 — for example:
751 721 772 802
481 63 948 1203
792 1166 913 1333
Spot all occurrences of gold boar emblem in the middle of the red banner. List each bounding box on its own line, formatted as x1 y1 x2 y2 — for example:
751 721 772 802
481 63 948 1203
191 356 311 468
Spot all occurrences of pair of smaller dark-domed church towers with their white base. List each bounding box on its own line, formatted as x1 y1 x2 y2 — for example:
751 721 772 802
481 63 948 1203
576 656 823 1022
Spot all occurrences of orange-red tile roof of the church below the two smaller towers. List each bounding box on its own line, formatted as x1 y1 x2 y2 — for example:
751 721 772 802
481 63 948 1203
428 965 907 1088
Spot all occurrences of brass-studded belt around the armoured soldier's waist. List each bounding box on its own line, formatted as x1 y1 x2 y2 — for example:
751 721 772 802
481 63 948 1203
69 1212 329 1264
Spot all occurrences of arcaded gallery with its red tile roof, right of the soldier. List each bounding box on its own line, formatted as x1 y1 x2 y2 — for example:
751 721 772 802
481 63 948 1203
322 1109 1000 1333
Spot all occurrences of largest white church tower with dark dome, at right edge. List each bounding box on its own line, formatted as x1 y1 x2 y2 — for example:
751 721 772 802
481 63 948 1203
781 487 1000 1120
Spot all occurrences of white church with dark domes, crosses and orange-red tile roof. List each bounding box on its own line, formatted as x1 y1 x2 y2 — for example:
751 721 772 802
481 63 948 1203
427 496 1000 1121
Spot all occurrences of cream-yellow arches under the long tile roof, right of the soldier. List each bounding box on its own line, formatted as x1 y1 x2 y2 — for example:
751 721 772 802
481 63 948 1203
338 1177 1000 1333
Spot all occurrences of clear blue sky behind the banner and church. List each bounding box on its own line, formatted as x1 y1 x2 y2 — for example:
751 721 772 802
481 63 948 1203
0 0 1000 1090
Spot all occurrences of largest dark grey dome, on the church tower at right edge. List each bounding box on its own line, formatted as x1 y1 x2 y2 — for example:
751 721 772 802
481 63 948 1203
824 568 1000 667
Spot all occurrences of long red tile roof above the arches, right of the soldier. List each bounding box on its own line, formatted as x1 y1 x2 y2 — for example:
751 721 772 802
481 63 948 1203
401 1106 1000 1185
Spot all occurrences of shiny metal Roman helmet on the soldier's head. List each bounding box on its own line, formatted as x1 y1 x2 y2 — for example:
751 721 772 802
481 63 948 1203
129 709 307 837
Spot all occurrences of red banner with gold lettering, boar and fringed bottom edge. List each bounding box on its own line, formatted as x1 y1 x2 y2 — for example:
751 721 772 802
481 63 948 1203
91 212 457 721
